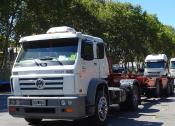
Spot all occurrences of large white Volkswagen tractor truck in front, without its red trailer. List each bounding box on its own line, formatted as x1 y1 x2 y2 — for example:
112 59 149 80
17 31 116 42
8 26 140 124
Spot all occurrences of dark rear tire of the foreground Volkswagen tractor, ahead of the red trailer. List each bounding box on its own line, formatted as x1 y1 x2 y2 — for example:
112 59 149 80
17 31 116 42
120 85 140 111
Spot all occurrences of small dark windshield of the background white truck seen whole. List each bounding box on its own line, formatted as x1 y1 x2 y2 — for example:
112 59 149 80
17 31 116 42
145 61 165 68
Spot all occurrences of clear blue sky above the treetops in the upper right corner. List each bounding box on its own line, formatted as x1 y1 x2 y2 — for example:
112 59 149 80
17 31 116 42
113 0 175 28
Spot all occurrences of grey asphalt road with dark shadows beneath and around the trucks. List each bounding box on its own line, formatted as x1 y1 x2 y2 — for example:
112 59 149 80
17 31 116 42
0 95 175 126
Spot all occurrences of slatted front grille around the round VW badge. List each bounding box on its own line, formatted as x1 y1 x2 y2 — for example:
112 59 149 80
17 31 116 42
19 77 63 90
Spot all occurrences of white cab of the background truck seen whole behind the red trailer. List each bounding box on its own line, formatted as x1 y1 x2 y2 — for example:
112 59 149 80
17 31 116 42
144 54 168 77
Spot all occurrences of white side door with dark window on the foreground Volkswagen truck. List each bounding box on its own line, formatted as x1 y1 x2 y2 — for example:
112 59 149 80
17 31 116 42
79 40 99 93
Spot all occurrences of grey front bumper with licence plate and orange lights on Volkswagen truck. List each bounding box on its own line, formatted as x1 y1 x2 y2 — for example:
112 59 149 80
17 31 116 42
8 96 86 120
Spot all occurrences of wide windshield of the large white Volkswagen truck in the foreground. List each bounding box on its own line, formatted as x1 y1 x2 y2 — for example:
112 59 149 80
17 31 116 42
17 38 78 66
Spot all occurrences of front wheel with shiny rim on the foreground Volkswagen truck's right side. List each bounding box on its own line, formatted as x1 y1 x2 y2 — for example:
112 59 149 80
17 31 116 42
90 90 108 125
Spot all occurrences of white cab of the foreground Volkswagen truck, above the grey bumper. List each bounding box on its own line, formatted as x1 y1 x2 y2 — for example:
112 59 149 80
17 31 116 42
11 27 109 96
